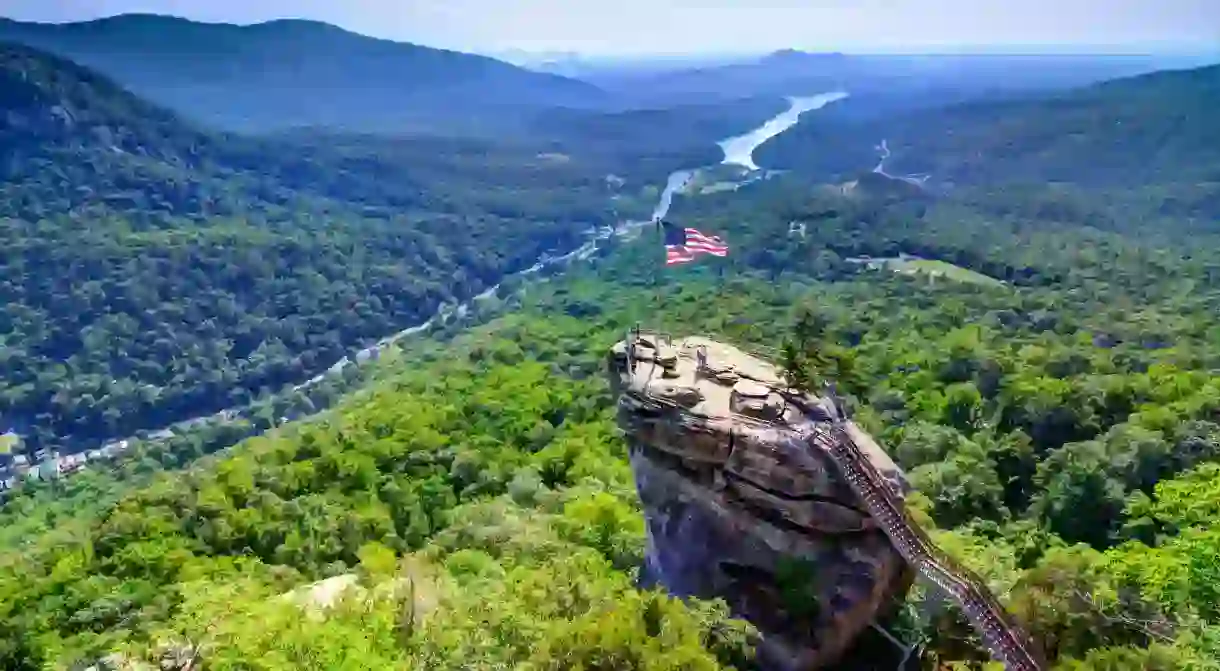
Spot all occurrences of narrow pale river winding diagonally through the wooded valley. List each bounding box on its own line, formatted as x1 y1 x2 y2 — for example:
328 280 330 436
76 93 848 458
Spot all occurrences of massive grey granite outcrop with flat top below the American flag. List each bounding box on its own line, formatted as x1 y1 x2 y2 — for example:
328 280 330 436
608 333 913 671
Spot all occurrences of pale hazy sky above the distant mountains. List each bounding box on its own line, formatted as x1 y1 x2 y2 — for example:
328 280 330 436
0 0 1220 55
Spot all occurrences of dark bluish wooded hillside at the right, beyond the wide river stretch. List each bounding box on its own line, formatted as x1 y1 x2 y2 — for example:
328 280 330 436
759 66 1220 193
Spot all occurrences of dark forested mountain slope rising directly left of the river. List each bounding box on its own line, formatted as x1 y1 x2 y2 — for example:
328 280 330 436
0 45 644 449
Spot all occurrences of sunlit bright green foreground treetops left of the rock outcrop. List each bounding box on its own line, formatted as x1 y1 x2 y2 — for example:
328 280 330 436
0 320 750 670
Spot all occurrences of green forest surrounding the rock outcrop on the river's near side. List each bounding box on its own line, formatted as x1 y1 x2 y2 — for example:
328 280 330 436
0 183 1220 670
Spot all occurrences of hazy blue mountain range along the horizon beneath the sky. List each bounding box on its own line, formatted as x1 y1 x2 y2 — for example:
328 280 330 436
0 15 1205 137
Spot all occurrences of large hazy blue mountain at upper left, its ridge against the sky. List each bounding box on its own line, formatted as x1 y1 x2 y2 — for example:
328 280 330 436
0 15 604 132
